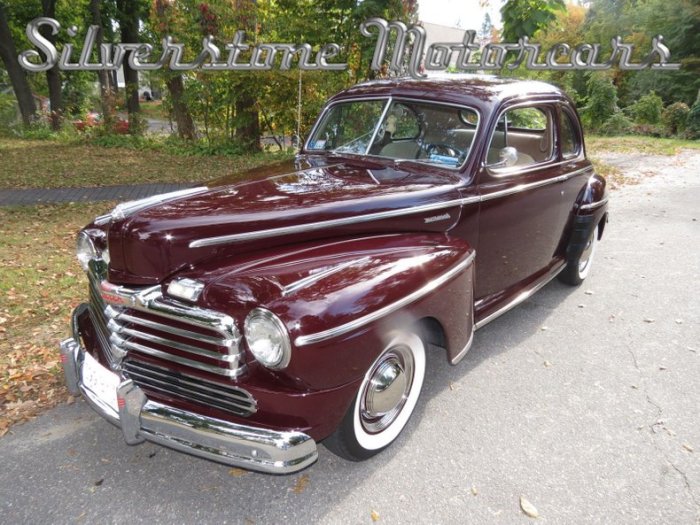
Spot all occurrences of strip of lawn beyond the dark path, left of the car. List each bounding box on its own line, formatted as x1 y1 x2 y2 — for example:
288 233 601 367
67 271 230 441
0 138 289 189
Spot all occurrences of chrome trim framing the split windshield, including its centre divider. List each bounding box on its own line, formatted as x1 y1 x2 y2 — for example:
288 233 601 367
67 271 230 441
304 95 482 172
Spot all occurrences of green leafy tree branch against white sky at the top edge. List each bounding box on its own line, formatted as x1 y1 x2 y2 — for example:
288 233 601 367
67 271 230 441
501 0 566 42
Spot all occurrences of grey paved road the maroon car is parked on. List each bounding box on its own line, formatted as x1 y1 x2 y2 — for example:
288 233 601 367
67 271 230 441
0 149 700 525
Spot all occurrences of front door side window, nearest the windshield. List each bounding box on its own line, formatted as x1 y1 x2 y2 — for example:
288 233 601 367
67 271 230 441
487 106 554 169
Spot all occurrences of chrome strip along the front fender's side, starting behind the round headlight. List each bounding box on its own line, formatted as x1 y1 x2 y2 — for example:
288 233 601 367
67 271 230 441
294 252 476 346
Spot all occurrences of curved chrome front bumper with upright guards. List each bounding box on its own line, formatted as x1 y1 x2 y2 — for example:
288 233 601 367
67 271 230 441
60 307 318 474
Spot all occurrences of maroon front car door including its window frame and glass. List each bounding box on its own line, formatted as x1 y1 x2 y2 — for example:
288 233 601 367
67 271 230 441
475 102 575 313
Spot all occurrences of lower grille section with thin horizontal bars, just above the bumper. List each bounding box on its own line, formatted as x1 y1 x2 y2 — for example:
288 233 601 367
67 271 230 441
123 358 257 417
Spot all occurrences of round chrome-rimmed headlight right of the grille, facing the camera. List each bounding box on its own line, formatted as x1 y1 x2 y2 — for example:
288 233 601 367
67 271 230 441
244 308 292 369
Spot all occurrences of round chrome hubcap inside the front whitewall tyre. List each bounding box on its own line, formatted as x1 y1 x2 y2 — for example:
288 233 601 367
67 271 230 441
360 346 414 433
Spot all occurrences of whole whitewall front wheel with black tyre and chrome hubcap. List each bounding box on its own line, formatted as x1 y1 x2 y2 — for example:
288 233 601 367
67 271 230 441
324 332 425 461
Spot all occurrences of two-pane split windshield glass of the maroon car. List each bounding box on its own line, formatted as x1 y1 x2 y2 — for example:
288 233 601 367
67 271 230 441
307 99 479 168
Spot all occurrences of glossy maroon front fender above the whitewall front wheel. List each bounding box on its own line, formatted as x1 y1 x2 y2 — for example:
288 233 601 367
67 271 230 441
193 233 474 390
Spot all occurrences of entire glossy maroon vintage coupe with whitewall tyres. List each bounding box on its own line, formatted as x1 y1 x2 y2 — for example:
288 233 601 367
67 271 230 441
61 76 607 473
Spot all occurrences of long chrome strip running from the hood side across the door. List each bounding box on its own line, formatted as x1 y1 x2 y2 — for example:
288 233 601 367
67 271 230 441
189 166 593 248
